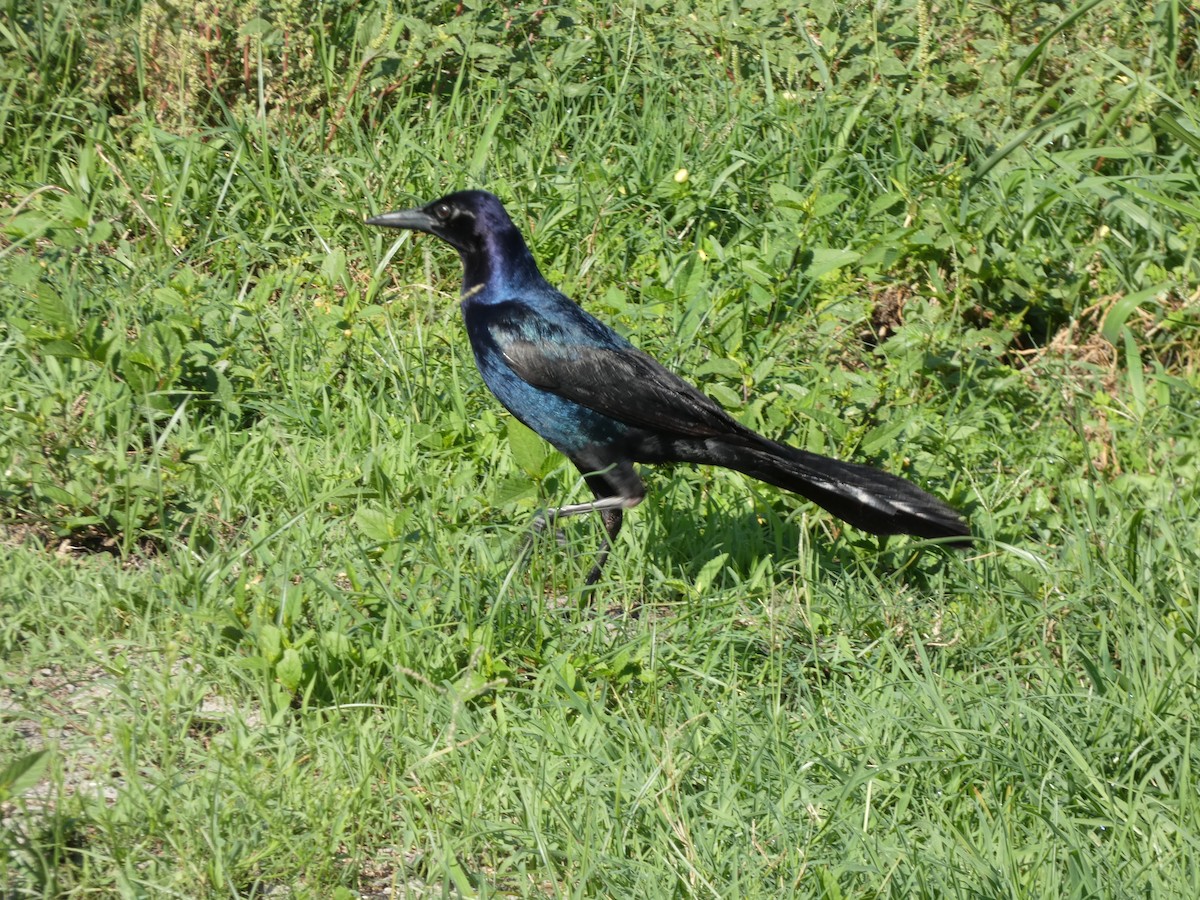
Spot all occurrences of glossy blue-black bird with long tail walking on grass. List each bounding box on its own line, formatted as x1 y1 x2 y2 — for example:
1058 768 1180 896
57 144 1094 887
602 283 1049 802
367 191 970 584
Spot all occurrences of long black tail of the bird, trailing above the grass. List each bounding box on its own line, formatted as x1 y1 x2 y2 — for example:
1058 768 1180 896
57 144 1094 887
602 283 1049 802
676 432 971 546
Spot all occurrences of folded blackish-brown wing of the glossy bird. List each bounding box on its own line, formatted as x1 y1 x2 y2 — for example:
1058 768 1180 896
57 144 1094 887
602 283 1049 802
488 301 742 437
